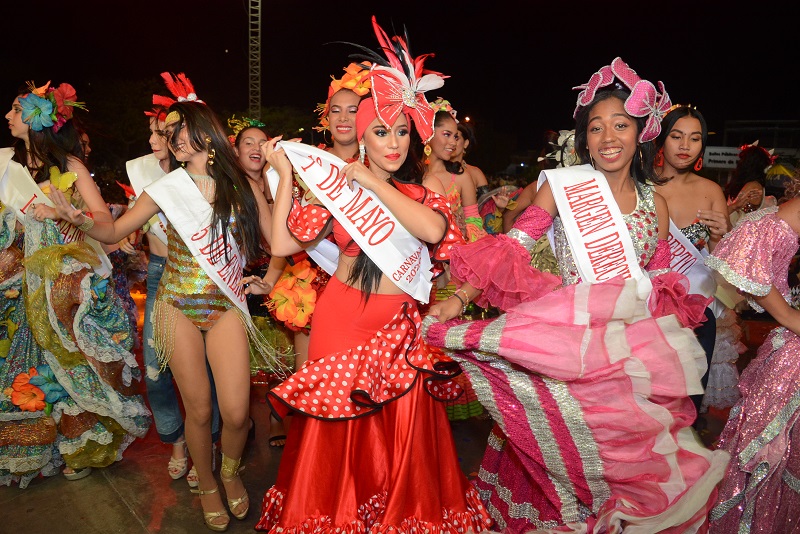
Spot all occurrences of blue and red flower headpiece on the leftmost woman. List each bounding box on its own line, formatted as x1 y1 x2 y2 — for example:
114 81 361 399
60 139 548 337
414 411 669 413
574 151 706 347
19 82 86 132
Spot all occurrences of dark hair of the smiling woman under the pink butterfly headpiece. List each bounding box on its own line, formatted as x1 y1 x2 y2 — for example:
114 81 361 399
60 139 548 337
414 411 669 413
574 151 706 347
575 87 665 184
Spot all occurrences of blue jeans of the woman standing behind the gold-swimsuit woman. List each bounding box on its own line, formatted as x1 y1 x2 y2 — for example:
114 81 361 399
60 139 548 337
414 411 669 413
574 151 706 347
142 254 220 443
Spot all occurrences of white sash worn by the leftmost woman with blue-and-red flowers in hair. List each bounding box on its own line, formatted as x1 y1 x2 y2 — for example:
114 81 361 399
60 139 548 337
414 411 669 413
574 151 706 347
0 148 112 278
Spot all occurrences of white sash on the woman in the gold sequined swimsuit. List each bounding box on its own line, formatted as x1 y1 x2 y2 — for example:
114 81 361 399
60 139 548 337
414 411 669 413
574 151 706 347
144 169 250 317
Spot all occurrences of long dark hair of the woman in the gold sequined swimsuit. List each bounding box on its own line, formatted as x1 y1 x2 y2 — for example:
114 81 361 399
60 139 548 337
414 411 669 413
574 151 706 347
169 102 261 260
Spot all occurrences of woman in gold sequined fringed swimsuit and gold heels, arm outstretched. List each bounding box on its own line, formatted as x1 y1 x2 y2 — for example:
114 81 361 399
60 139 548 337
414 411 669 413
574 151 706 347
54 84 284 531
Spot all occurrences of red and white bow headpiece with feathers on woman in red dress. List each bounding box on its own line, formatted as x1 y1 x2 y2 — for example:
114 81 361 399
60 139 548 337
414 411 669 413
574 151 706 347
360 16 447 143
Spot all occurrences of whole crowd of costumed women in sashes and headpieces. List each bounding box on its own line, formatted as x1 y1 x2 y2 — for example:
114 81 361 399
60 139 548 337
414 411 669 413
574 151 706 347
0 12 800 534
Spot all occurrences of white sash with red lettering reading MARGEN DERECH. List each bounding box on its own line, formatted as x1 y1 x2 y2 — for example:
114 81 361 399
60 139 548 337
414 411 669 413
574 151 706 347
539 165 653 298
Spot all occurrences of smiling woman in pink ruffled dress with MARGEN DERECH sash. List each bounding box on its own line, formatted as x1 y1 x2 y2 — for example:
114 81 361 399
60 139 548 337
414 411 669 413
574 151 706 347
423 58 727 533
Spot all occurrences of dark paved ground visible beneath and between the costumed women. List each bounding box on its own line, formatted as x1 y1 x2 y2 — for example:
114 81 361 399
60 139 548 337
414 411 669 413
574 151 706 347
0 292 775 534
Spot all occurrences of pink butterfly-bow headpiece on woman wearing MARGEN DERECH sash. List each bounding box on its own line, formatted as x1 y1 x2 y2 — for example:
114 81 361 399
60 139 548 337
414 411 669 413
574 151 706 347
572 57 672 143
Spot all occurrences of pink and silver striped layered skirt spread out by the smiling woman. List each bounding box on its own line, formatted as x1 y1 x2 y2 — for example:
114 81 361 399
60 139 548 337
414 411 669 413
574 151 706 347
424 279 729 534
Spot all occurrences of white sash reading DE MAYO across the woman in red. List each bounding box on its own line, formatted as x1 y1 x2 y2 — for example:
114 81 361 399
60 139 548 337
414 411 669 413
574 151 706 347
278 141 433 303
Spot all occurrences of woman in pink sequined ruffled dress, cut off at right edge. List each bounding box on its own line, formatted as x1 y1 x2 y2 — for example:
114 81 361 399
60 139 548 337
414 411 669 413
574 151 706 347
706 183 800 534
